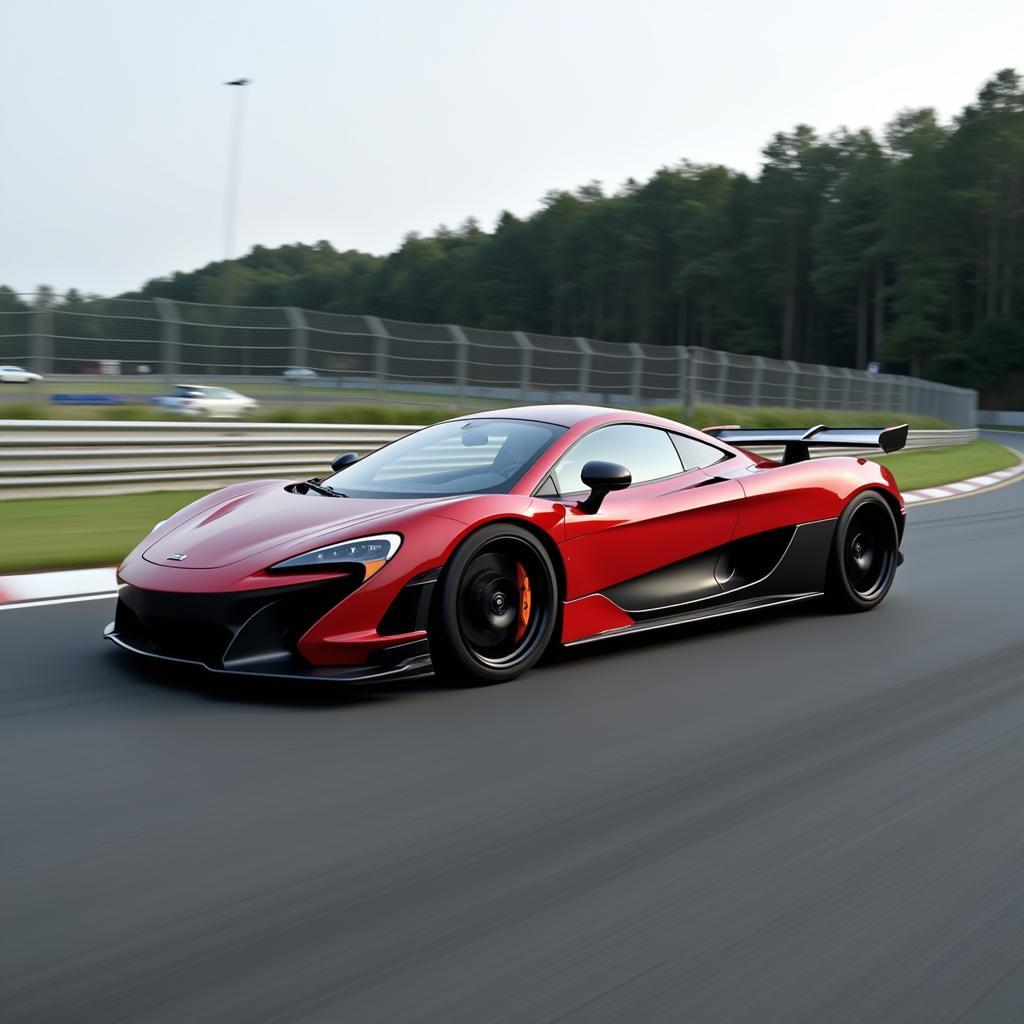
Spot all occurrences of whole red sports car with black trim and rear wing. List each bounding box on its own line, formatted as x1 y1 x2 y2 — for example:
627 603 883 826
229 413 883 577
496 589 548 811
105 406 907 682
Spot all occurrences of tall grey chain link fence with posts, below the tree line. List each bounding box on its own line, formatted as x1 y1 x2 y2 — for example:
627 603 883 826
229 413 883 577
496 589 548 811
0 299 977 427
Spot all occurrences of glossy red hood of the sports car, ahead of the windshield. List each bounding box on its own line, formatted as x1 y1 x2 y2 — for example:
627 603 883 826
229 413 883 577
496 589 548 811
142 484 451 569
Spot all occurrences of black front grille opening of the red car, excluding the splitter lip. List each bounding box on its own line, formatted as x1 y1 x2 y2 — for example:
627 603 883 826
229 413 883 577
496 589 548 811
115 579 357 667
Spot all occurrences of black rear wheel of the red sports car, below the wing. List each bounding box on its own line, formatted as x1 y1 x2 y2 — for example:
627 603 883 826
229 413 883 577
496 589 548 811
825 490 899 611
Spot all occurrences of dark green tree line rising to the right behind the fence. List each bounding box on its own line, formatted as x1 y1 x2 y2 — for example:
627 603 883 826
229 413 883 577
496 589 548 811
0 70 1024 404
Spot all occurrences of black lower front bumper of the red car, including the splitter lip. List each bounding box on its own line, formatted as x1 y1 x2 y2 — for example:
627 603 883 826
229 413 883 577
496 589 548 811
103 580 432 683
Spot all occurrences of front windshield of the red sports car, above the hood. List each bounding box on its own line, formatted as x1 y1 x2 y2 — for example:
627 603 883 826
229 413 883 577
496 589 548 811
322 419 565 498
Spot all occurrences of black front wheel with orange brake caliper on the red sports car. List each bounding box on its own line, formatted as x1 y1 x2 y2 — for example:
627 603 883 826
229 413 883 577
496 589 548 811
428 523 558 686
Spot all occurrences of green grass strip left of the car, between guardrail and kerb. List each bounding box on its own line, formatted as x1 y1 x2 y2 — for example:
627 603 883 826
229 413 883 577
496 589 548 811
0 490 206 572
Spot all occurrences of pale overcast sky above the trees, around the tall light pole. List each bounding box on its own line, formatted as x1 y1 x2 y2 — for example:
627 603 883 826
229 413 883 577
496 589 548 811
0 0 1024 294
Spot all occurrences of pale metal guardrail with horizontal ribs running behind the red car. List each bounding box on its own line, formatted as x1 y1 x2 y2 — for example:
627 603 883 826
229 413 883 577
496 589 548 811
0 420 978 500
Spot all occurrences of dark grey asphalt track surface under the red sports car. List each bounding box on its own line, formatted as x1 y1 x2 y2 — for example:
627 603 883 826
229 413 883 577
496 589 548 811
0 444 1024 1024
